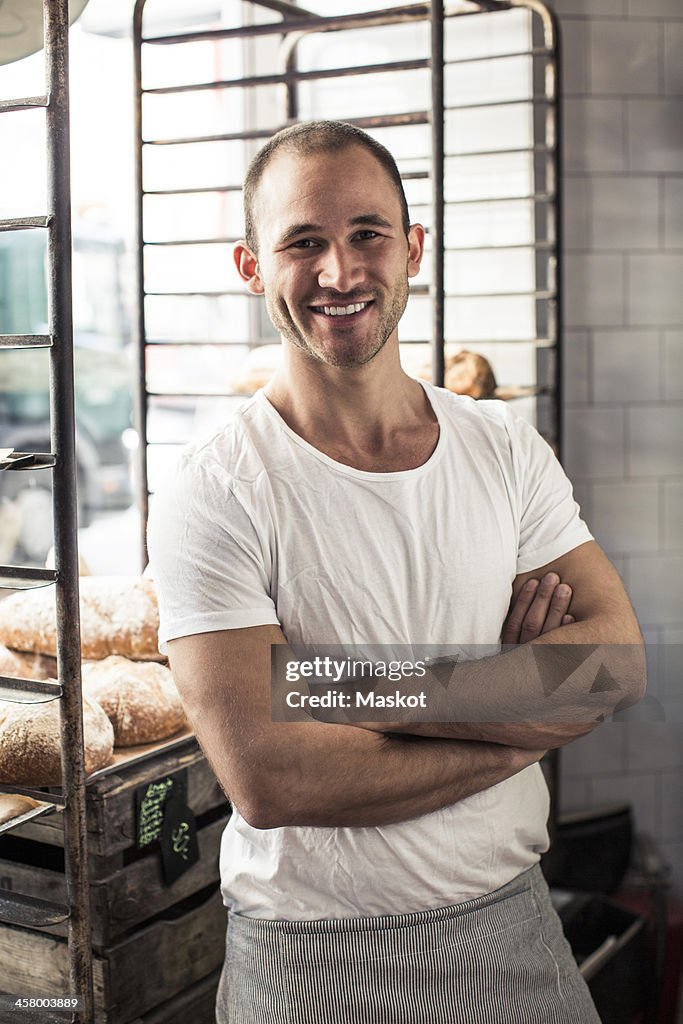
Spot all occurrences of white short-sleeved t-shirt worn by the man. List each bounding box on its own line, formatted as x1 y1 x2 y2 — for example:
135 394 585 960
150 384 591 920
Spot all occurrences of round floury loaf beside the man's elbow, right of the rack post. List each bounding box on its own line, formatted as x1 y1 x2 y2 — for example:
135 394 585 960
83 655 186 746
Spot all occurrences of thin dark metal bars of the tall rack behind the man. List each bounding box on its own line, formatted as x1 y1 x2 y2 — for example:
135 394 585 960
133 0 561 563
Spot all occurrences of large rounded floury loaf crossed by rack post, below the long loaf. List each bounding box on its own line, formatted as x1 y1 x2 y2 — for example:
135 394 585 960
0 695 114 786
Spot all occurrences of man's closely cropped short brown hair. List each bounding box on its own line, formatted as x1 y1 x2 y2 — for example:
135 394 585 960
243 121 411 252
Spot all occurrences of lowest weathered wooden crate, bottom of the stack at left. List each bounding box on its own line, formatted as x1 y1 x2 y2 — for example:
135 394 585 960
0 889 226 1024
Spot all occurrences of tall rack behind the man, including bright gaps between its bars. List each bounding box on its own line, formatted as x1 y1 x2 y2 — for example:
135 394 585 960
133 0 561 569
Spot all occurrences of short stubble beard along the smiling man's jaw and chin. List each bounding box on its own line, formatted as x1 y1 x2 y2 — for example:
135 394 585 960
266 281 409 369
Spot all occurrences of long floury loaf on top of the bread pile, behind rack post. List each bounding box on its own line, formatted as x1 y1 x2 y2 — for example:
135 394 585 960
0 577 161 659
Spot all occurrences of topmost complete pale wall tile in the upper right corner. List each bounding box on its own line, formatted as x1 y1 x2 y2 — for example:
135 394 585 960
590 20 659 95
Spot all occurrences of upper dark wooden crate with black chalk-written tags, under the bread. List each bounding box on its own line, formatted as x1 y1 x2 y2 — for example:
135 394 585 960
0 739 230 950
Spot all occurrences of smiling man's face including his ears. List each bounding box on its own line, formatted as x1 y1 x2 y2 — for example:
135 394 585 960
236 145 424 367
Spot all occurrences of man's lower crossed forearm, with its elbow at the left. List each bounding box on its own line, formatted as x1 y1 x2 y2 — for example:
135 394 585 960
180 705 543 828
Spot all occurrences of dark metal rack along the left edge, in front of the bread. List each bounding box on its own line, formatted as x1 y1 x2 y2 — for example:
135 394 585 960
0 0 93 1024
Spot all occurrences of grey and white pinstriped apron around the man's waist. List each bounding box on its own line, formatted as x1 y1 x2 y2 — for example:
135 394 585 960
216 865 600 1024
